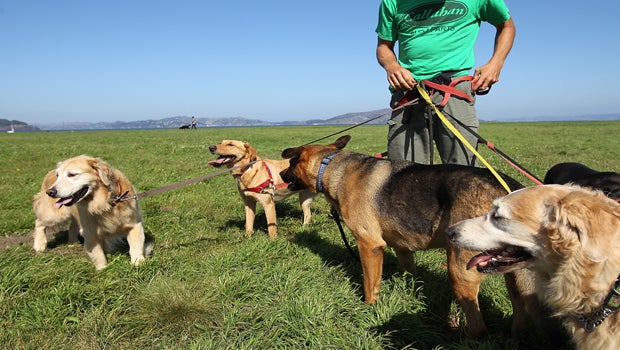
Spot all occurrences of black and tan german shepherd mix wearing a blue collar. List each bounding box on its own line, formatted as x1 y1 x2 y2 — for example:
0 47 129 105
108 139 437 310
282 135 534 336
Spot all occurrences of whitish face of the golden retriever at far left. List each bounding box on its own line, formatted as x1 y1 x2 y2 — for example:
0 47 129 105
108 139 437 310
46 156 107 208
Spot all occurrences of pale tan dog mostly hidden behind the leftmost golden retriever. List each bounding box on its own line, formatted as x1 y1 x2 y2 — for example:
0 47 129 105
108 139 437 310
32 170 80 253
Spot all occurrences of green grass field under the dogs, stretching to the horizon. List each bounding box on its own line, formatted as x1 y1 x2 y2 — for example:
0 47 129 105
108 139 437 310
0 121 620 349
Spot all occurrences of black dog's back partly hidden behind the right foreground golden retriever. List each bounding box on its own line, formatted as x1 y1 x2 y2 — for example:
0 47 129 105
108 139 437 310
544 163 620 200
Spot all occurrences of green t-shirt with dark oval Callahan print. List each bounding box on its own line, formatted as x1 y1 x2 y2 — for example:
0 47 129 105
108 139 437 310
375 0 510 80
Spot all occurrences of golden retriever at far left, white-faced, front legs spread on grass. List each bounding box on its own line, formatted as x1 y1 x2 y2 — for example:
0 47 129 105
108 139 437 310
46 155 152 270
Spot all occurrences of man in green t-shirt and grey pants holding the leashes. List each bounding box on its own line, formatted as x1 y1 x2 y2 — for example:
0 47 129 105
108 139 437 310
376 0 516 166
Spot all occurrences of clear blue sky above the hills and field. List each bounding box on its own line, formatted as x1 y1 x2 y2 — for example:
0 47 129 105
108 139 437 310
0 0 620 125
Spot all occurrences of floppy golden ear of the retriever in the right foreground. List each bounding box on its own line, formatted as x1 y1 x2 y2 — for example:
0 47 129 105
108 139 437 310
543 191 620 262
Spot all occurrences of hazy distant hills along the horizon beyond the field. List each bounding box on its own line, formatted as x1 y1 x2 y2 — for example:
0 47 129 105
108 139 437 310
0 108 620 131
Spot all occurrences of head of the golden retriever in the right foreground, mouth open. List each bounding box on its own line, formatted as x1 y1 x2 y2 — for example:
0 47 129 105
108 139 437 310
447 185 620 274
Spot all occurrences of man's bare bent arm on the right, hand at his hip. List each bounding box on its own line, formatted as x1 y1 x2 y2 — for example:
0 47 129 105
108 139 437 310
472 18 517 91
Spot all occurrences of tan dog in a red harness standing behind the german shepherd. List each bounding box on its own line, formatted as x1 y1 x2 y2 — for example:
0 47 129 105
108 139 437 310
209 140 315 238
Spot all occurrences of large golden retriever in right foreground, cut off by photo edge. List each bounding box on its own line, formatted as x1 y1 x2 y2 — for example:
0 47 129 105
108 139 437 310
448 185 620 350
